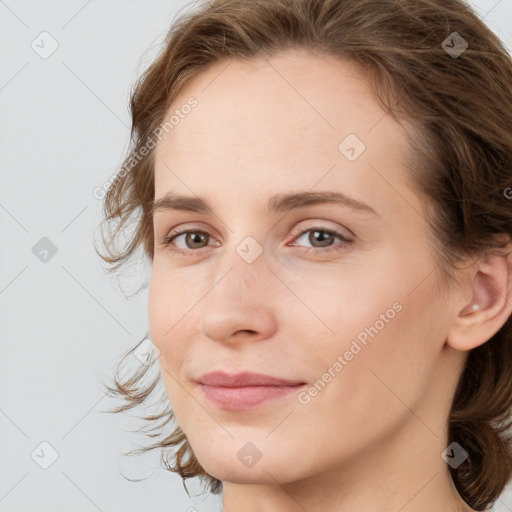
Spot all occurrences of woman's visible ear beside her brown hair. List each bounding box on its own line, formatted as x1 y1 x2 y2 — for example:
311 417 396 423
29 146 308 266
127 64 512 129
446 242 512 351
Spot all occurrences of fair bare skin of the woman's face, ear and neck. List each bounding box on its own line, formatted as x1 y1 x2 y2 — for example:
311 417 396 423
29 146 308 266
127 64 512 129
149 51 512 512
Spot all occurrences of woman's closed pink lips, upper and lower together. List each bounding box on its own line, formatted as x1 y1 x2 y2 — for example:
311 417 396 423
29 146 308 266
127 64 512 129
198 372 305 410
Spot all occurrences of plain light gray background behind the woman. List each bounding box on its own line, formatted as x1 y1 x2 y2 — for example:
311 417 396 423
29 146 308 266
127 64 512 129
0 0 512 512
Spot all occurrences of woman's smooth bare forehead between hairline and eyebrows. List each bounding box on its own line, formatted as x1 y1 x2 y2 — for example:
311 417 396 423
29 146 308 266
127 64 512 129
155 51 416 214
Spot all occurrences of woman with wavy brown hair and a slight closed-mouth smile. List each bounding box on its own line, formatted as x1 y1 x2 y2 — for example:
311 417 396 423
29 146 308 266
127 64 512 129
98 0 512 512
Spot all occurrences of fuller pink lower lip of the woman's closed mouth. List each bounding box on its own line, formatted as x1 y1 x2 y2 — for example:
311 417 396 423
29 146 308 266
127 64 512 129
201 384 304 411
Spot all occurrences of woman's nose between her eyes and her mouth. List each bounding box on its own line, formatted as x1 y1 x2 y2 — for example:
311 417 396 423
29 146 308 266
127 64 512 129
199 244 277 343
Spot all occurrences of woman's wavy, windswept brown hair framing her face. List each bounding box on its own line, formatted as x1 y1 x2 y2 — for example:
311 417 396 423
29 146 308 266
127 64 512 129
100 0 512 510
